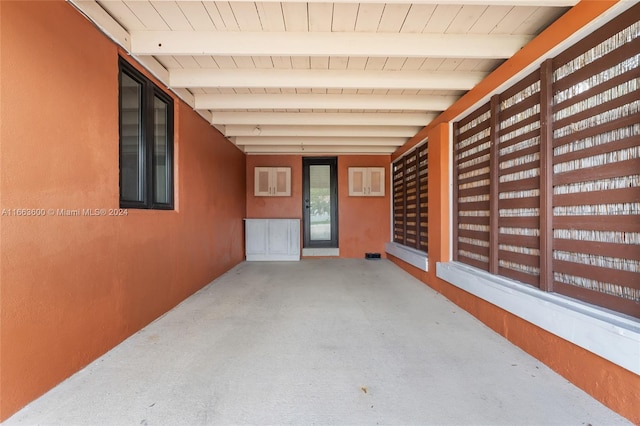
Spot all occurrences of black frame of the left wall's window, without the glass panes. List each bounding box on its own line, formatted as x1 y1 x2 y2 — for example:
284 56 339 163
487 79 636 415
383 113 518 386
118 57 175 210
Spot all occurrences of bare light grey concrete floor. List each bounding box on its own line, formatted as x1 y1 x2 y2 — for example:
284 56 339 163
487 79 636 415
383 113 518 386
4 259 630 426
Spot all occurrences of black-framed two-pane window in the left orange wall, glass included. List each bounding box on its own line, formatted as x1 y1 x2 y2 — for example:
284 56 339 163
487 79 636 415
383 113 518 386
119 58 173 210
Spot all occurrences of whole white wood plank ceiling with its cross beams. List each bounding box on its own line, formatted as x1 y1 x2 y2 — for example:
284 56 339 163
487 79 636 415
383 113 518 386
71 0 577 154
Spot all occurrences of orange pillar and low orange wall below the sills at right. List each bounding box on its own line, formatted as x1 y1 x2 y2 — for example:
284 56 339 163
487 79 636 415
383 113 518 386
389 123 640 424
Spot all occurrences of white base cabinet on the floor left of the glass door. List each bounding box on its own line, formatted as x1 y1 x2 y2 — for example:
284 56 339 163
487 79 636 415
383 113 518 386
244 219 300 261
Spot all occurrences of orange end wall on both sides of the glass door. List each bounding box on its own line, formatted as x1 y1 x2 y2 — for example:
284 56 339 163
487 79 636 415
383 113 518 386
246 155 391 258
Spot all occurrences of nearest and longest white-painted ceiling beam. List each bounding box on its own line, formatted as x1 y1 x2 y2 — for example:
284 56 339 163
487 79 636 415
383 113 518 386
131 31 533 59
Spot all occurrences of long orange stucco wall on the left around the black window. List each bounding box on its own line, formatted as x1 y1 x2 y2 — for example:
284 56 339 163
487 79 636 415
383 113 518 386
0 1 245 420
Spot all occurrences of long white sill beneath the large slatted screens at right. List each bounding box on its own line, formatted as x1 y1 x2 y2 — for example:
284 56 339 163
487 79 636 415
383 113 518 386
436 262 640 374
